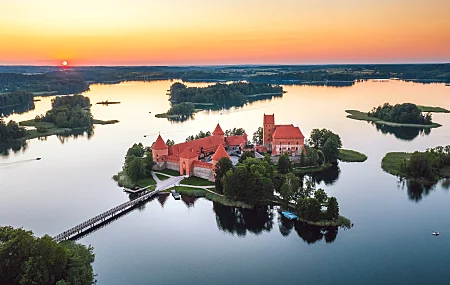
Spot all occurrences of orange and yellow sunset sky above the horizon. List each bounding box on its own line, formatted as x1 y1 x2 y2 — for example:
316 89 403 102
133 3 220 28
0 0 450 65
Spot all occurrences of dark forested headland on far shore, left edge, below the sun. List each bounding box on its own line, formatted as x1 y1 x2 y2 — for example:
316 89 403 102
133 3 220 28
0 71 89 95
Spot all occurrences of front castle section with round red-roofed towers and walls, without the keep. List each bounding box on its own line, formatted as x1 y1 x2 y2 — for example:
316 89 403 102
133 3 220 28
152 124 247 181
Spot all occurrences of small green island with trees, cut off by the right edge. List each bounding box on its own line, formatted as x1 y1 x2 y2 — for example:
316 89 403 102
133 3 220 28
381 145 450 185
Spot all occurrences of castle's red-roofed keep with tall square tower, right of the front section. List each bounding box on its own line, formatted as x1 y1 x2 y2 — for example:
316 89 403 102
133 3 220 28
263 114 305 156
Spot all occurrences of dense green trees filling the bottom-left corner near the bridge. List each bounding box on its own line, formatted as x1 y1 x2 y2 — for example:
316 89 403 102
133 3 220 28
0 227 94 285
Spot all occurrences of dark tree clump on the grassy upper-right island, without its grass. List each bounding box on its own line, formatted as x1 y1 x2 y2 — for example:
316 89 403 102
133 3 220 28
367 103 433 125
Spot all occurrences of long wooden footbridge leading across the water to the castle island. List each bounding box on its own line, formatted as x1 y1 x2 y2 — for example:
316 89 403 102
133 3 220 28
53 176 184 242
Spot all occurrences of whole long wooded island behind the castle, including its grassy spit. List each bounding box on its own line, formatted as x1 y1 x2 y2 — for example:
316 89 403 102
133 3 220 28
155 82 284 120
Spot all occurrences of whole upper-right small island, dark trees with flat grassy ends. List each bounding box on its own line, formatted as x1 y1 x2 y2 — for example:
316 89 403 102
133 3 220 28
345 103 450 129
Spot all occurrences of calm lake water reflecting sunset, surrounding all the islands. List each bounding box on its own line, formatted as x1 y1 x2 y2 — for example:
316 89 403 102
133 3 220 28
0 81 450 285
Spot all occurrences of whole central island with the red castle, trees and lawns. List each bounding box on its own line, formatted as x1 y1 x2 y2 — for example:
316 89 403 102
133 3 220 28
113 115 360 227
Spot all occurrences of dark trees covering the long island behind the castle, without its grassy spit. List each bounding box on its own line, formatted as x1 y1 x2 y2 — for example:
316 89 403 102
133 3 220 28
170 82 283 105
